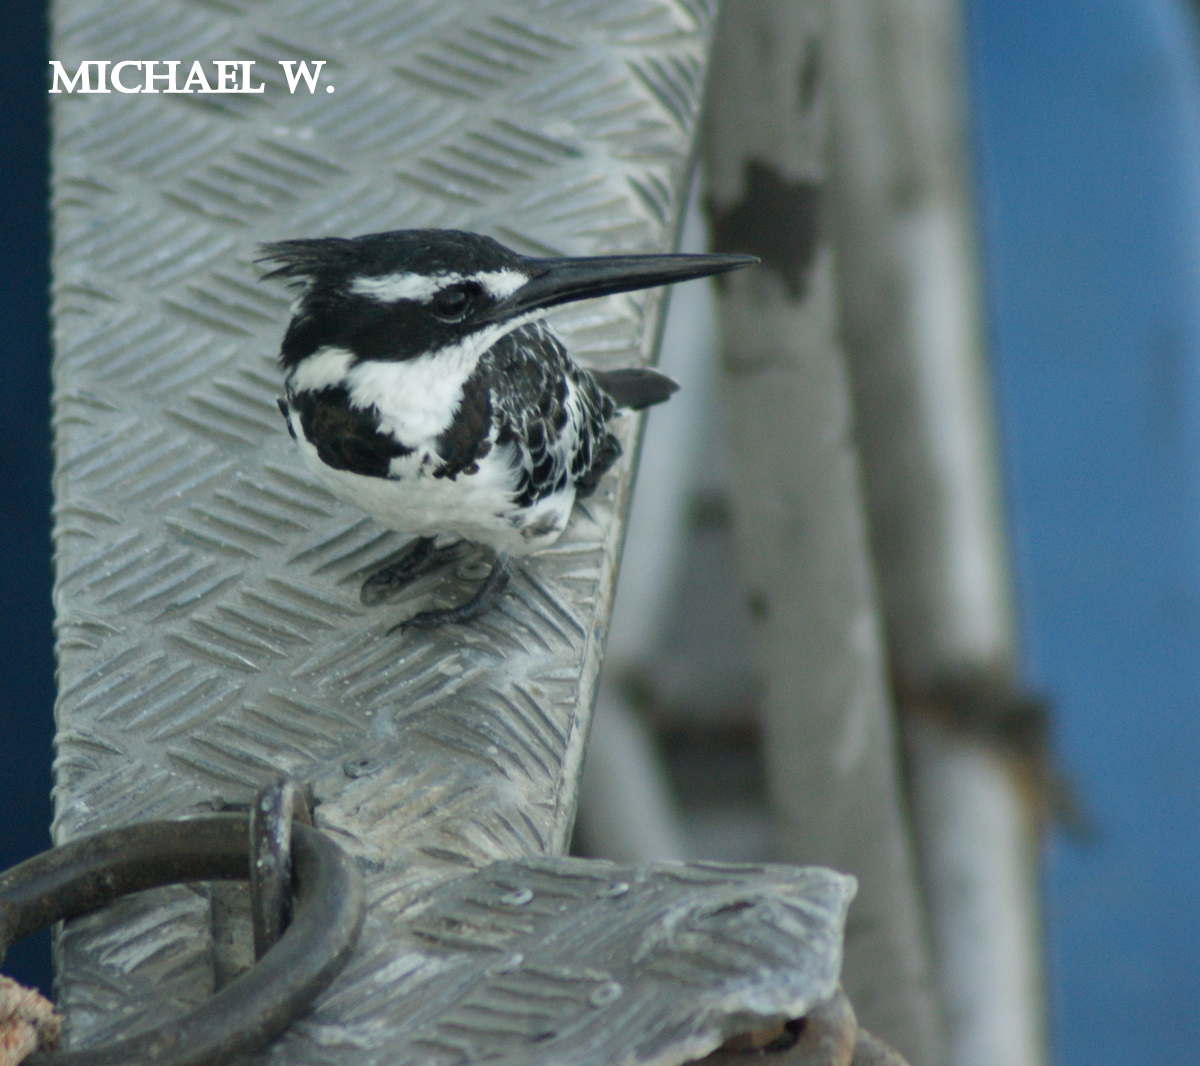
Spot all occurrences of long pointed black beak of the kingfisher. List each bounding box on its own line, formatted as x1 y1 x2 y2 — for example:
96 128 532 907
488 256 758 319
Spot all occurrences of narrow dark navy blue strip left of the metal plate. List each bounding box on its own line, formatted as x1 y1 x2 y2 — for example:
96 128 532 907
0 4 54 989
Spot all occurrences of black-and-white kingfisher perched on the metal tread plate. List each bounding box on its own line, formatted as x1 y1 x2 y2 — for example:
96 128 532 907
256 229 758 629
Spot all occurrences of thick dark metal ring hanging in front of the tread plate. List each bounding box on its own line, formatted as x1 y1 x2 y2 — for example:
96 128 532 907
0 815 365 1066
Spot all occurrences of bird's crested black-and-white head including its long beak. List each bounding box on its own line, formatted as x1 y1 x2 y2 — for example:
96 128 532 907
259 229 757 367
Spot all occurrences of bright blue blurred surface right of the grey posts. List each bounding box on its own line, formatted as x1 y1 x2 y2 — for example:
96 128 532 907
970 0 1200 1066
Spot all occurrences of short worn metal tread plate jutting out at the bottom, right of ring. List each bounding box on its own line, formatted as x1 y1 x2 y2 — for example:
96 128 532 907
270 857 853 1066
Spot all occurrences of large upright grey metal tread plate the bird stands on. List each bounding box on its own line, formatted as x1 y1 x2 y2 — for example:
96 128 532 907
50 0 859 1062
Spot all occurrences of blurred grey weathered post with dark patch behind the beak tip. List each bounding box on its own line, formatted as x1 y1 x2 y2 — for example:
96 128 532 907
707 0 942 1064
